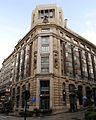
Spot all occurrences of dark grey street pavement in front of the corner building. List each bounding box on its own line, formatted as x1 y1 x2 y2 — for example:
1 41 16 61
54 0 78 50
0 111 84 120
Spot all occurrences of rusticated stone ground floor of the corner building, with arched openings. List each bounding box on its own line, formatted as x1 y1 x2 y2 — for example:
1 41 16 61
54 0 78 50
12 75 96 111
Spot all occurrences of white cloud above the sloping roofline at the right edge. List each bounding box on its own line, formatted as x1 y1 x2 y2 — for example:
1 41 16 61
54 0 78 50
76 10 96 45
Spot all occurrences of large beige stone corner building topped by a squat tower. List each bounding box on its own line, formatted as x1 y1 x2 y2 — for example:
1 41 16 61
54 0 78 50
0 5 96 111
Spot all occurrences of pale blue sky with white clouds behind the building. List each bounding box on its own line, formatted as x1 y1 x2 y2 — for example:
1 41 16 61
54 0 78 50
0 0 96 68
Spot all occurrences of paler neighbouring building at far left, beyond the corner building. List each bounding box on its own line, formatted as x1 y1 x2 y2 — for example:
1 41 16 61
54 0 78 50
0 52 14 109
